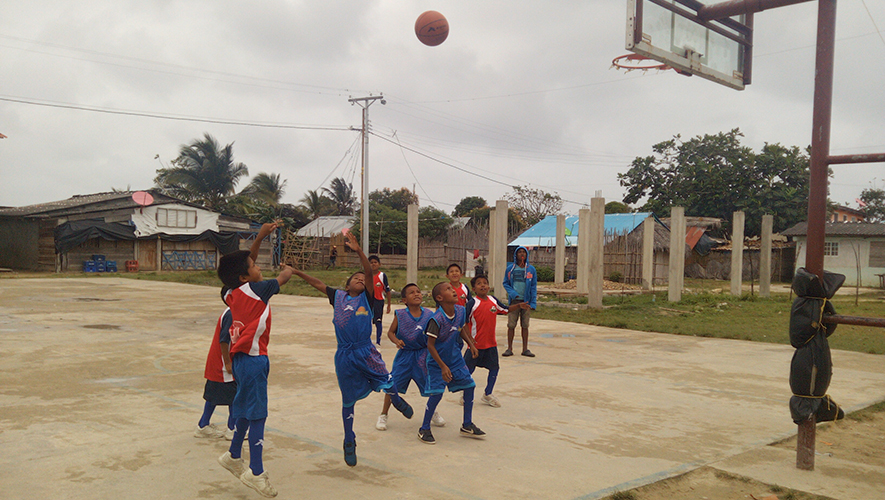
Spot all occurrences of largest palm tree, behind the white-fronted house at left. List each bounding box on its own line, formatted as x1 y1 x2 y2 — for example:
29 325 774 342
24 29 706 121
154 133 249 210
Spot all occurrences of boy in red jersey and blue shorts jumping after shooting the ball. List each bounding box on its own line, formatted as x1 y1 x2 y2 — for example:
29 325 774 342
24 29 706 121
218 223 292 497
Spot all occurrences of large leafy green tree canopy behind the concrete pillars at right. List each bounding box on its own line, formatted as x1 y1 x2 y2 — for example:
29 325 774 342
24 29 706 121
618 129 809 235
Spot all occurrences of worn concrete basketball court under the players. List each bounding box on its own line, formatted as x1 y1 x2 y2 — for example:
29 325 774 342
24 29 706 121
0 278 885 500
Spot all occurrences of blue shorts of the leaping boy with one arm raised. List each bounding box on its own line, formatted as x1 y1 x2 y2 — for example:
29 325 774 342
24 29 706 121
335 339 393 408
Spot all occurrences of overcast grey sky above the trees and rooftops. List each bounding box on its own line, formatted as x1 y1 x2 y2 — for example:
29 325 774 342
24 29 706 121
0 0 885 217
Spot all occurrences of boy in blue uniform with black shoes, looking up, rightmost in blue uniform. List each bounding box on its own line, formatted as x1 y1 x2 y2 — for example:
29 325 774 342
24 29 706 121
418 282 485 444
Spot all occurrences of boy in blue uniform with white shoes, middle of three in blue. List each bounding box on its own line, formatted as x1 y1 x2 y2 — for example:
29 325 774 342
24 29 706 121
375 283 446 431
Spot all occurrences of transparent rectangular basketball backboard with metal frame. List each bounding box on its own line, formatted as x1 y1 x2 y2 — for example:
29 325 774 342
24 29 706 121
627 0 753 90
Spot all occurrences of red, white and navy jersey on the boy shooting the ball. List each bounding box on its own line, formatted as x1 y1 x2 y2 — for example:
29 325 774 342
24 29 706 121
225 279 280 356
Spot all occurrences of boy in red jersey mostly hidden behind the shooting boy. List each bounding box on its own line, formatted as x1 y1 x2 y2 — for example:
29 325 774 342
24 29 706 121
194 307 237 439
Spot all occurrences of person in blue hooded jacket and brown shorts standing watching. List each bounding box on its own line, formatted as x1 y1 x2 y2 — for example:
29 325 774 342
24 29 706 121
501 246 538 358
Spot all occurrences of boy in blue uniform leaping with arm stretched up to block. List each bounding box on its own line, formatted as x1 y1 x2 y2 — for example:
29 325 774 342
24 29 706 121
294 233 414 467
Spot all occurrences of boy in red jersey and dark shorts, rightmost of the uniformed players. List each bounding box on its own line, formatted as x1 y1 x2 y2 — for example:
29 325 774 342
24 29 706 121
464 276 508 408
